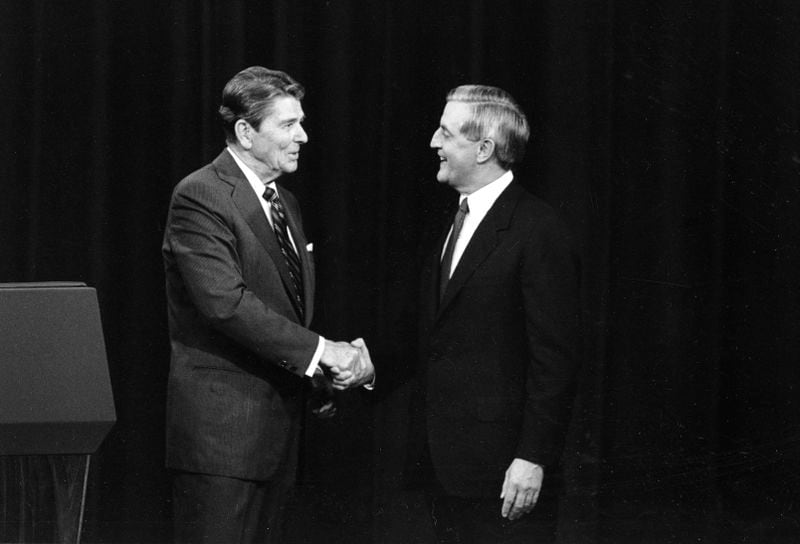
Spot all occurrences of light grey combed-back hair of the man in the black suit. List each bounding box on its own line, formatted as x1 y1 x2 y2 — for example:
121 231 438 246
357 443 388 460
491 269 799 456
447 85 530 170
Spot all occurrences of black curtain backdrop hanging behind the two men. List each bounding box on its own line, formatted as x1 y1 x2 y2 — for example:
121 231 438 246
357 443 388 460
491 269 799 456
0 0 800 543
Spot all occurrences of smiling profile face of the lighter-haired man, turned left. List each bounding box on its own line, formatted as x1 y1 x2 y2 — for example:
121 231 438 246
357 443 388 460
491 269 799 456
431 102 480 193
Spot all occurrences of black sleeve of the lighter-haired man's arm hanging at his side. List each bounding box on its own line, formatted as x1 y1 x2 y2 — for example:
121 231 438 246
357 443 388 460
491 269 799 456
517 212 582 466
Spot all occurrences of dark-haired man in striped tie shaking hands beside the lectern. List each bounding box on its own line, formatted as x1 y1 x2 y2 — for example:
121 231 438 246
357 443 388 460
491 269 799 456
162 66 373 544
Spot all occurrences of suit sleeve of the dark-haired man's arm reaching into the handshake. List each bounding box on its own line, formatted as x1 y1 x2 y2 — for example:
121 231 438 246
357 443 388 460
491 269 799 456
166 176 319 376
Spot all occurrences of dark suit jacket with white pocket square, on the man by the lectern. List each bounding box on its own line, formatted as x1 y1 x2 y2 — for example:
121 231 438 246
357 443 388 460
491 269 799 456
162 150 319 480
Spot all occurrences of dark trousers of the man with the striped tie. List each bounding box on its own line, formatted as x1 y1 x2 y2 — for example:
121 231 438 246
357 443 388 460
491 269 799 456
173 472 293 544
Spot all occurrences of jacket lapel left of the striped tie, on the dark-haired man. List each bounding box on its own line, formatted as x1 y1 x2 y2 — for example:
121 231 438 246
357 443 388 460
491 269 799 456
214 150 305 318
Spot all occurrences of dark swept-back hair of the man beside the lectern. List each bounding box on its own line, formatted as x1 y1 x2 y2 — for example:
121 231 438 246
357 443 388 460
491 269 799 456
218 66 305 143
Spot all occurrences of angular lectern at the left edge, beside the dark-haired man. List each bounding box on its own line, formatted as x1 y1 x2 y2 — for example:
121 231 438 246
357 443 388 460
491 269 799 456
0 283 116 542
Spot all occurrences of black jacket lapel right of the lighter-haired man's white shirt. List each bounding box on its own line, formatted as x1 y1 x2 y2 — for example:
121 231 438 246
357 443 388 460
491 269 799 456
436 183 522 318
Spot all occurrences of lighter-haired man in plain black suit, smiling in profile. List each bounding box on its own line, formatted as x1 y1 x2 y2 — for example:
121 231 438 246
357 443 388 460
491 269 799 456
418 85 580 544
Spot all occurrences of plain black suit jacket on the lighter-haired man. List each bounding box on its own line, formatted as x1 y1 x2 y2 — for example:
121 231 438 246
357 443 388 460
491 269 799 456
420 182 580 497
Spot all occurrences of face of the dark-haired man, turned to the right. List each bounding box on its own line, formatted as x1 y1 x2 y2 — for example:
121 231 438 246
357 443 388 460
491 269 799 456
245 96 308 182
